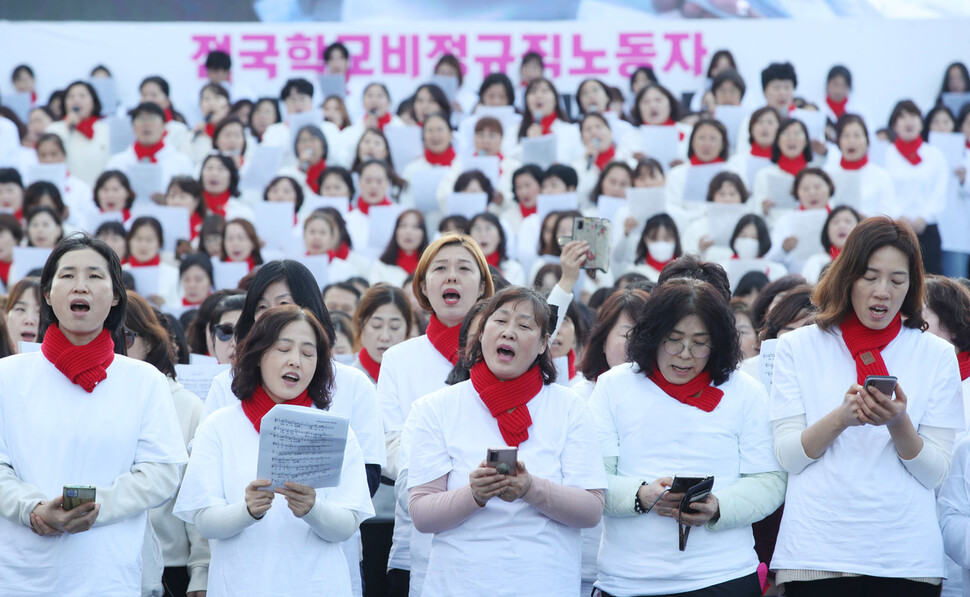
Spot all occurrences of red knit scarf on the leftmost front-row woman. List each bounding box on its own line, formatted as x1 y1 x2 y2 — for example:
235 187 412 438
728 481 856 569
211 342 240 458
40 323 115 393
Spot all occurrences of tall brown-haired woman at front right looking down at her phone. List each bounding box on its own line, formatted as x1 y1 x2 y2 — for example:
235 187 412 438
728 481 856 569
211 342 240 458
771 217 964 597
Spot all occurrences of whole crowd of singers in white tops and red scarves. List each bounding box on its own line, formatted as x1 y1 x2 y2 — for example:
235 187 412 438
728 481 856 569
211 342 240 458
0 43 970 597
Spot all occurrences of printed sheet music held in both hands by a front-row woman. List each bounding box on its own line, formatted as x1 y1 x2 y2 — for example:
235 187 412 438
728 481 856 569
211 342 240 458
256 404 349 489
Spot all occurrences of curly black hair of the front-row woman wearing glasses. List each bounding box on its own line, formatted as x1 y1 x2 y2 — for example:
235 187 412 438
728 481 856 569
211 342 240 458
627 278 742 385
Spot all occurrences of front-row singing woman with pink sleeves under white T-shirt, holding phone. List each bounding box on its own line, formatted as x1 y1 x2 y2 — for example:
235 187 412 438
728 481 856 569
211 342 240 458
405 287 605 595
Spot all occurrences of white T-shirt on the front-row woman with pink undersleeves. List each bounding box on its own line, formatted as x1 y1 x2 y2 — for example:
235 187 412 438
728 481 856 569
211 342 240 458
402 376 606 597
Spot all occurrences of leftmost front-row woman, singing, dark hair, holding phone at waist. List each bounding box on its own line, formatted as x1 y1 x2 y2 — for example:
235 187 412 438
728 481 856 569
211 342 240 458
0 235 186 595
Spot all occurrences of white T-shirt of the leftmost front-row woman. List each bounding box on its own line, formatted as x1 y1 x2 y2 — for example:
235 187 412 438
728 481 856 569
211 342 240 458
0 352 187 597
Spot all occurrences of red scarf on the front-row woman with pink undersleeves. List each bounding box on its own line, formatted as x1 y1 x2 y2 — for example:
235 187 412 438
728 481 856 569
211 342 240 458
471 361 542 447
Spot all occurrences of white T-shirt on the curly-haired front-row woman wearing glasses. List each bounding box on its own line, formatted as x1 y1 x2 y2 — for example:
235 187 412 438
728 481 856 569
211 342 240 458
589 363 780 595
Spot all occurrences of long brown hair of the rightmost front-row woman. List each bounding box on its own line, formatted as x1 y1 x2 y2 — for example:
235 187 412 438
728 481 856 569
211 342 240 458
812 216 926 330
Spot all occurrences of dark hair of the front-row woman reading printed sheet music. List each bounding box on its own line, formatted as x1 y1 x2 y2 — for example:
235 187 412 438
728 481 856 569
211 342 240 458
232 305 333 410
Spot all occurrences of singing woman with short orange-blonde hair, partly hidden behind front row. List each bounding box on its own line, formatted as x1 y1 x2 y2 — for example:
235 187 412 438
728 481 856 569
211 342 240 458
377 234 494 595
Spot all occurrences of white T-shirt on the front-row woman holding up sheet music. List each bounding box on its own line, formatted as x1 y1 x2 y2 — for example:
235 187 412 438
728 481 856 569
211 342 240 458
175 401 374 597
